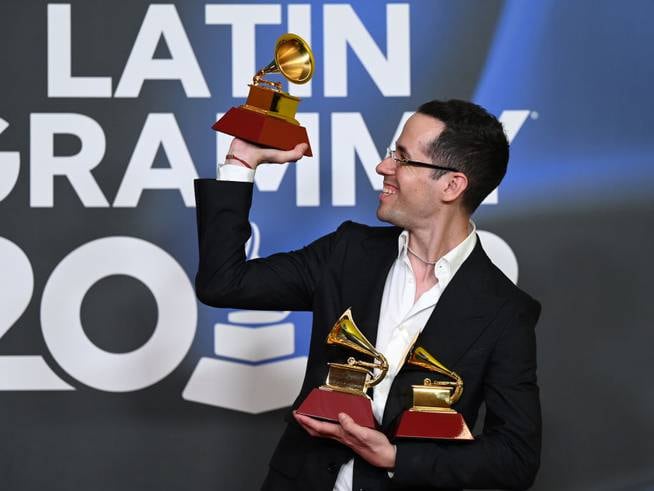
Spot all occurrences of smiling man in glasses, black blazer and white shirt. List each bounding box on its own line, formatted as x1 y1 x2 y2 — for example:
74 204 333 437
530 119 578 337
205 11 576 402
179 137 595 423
196 100 541 491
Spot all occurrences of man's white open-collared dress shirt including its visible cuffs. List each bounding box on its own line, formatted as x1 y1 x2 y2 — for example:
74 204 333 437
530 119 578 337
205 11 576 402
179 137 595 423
218 164 477 491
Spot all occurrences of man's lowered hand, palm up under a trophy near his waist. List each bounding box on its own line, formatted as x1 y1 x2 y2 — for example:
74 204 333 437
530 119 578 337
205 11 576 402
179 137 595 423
293 411 395 470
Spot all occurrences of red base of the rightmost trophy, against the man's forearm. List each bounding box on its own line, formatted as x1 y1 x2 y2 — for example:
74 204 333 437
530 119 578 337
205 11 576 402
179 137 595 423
395 411 474 440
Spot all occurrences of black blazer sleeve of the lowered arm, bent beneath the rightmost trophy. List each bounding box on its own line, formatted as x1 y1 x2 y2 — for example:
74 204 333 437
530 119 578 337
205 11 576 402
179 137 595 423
392 298 541 489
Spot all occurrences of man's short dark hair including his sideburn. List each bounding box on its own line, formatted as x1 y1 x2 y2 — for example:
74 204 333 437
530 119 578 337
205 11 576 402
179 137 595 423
418 99 509 213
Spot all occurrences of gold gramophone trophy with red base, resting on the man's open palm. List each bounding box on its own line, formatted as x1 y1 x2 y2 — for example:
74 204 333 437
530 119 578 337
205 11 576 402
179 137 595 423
297 309 388 428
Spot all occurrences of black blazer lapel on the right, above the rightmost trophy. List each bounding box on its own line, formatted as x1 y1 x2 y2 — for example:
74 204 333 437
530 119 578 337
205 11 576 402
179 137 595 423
382 242 505 427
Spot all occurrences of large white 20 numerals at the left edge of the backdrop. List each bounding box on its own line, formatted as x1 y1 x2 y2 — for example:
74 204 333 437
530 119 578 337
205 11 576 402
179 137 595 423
0 237 197 392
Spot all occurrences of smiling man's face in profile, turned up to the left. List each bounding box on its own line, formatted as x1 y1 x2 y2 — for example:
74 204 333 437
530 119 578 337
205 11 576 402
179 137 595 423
377 113 445 230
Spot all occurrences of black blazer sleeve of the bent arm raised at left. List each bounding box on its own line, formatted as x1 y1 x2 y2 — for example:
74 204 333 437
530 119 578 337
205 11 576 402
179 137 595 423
195 179 342 310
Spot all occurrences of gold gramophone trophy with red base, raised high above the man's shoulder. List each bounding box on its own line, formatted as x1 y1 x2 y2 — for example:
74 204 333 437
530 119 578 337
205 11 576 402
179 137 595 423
212 33 315 157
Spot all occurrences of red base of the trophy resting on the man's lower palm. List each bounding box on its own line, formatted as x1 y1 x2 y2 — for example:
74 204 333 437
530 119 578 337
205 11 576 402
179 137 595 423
297 389 377 428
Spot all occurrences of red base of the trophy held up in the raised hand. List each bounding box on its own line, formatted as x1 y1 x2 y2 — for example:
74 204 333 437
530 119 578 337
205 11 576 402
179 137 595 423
212 107 313 157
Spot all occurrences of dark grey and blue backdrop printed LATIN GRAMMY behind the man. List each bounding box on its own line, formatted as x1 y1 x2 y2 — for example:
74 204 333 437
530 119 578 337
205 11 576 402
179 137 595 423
0 0 654 491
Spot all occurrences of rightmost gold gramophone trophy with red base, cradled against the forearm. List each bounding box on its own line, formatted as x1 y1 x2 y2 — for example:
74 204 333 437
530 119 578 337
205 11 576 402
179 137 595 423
395 347 474 440
